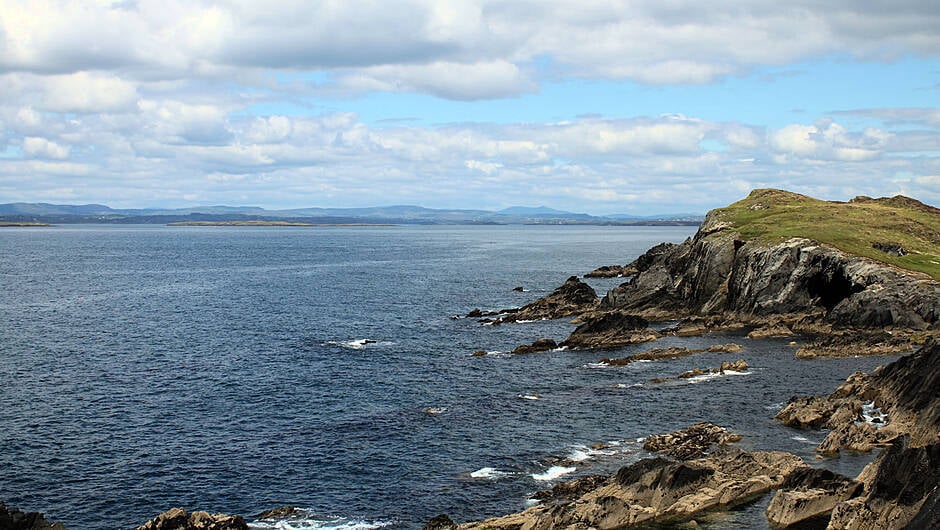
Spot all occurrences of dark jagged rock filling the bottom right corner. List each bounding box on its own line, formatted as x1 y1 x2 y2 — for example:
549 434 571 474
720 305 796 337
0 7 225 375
829 436 940 530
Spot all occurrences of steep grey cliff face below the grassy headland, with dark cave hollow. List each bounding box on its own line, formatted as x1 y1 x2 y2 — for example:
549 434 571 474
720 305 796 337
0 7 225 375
600 196 940 330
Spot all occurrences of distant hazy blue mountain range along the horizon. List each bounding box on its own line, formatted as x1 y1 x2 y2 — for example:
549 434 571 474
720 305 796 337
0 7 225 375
0 202 703 225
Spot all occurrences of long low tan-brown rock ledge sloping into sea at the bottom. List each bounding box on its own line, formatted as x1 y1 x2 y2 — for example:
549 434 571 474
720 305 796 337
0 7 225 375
459 447 805 530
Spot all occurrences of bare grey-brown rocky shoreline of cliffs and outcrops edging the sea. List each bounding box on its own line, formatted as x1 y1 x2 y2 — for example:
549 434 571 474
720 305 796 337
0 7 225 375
9 190 940 530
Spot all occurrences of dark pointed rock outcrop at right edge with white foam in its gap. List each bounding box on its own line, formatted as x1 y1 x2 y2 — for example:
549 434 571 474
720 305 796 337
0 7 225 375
776 339 940 453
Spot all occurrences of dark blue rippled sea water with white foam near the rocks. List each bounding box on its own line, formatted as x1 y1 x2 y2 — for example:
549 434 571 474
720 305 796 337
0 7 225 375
0 226 890 529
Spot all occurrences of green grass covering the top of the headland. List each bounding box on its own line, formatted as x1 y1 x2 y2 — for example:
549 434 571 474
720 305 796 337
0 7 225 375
715 189 940 280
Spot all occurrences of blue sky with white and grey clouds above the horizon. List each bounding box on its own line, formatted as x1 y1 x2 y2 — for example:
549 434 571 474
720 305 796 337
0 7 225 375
0 0 940 215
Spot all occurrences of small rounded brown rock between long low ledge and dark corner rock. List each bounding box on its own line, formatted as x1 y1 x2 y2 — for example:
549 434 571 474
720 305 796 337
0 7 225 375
765 467 862 527
